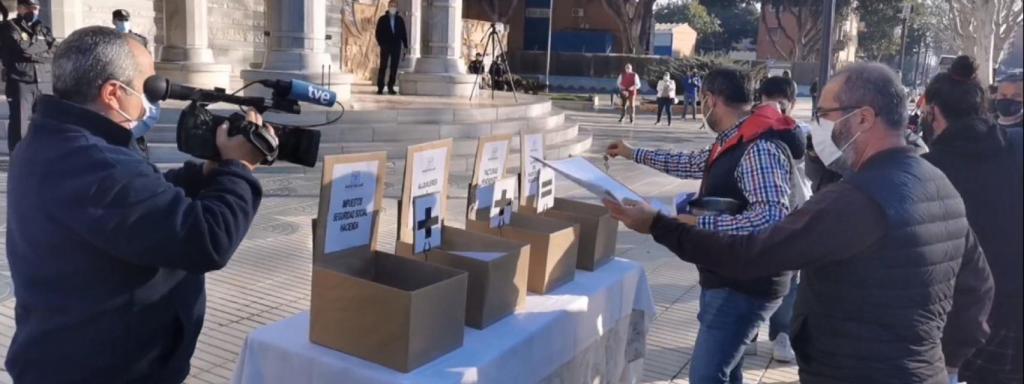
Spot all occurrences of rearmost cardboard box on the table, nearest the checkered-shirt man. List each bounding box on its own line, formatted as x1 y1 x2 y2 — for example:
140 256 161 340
541 198 618 270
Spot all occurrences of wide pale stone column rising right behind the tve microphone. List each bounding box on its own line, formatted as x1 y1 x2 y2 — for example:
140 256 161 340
242 0 352 99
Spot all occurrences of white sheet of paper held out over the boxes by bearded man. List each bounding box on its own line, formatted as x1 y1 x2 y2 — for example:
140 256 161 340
534 158 676 216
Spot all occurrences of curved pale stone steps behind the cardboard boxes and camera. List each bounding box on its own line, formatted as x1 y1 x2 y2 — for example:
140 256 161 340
0 94 592 195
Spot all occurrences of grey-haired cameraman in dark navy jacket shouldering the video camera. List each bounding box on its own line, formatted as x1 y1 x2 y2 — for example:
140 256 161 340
6 27 262 383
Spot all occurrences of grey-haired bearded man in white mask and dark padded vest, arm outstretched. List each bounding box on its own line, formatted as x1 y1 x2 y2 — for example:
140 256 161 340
605 63 993 384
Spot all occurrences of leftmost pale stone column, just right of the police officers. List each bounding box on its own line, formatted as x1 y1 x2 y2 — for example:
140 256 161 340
157 0 231 88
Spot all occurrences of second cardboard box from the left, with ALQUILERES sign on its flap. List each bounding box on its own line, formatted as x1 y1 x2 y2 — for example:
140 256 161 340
395 140 529 329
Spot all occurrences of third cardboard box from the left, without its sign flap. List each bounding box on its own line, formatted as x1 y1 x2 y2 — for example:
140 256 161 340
466 213 580 294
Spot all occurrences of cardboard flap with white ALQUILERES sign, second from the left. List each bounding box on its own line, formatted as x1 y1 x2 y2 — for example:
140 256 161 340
396 139 453 256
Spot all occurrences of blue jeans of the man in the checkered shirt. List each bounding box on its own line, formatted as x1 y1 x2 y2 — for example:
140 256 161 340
690 288 782 384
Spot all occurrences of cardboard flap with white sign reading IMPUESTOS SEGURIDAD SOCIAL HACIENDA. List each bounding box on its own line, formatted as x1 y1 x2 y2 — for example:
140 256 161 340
313 152 387 257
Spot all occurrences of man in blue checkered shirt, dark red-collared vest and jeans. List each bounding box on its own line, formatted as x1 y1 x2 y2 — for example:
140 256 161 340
607 68 806 384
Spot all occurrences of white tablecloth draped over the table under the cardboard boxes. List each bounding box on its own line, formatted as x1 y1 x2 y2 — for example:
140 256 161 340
233 259 654 384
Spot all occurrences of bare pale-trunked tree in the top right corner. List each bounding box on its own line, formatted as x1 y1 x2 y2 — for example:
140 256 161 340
940 0 1024 85
